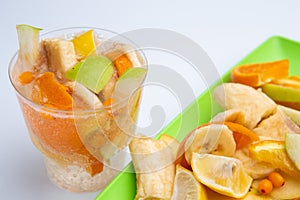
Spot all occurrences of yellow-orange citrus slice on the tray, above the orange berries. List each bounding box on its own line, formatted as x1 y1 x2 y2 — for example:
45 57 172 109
249 140 300 176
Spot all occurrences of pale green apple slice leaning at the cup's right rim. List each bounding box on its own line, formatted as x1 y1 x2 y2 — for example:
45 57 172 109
113 67 147 99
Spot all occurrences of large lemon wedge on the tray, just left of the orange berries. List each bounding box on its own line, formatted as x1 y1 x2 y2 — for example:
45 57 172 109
191 153 253 198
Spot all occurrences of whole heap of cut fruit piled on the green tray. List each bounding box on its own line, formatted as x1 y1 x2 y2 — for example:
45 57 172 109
130 60 300 200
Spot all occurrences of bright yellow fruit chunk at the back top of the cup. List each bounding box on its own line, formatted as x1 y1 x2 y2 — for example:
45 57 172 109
72 30 96 59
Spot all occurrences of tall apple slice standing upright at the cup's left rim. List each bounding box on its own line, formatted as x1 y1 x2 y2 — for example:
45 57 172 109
16 24 42 71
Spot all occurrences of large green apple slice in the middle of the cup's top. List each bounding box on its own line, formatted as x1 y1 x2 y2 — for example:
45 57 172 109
65 56 114 93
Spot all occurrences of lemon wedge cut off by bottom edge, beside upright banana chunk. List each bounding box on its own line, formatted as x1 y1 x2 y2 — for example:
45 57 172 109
172 165 207 200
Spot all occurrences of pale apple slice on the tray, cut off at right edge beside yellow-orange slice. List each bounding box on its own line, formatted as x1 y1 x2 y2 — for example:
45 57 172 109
285 133 300 170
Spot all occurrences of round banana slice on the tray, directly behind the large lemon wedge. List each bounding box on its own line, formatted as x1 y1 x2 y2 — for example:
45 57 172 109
184 124 236 164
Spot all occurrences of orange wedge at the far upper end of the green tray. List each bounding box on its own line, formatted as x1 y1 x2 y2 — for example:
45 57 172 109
231 59 289 87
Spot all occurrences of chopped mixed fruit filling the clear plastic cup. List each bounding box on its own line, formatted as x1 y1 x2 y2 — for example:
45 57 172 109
10 25 147 190
